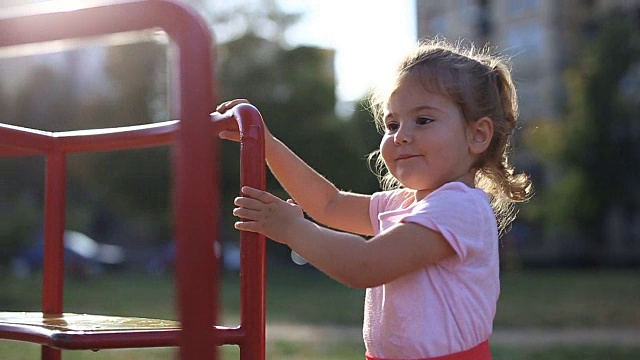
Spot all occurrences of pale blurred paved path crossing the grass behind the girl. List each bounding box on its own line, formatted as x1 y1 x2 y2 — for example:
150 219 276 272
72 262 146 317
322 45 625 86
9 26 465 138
267 324 640 346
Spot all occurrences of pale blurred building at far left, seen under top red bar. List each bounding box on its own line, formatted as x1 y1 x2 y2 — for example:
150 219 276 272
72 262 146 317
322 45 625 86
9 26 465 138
0 0 155 130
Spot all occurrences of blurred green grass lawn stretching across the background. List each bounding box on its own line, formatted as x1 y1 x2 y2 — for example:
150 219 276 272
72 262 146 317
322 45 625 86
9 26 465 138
0 266 640 360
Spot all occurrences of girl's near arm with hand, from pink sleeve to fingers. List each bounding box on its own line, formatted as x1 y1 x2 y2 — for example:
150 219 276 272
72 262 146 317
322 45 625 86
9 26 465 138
233 187 455 288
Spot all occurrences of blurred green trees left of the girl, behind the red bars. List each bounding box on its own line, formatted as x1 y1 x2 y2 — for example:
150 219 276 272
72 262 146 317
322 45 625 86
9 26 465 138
0 1 379 257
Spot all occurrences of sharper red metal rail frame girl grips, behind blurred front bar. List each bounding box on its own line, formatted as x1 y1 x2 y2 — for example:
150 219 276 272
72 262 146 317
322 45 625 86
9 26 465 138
0 104 266 360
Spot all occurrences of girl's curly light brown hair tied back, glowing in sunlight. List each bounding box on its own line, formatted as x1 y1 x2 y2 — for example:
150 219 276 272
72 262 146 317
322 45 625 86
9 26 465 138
369 39 533 233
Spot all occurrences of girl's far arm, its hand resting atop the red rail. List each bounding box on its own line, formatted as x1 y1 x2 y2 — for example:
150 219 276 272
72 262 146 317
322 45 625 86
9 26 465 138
216 99 373 235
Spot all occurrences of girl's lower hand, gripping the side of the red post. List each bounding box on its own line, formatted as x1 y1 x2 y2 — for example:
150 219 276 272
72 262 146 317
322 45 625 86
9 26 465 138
233 186 308 244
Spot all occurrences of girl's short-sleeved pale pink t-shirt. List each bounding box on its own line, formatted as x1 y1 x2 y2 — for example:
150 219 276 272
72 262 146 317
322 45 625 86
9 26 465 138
363 182 500 359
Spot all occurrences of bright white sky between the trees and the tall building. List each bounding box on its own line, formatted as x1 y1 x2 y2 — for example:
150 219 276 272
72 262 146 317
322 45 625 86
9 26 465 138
278 0 416 102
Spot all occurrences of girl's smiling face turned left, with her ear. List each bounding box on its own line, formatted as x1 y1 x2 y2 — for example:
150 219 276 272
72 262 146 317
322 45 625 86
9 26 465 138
380 79 475 200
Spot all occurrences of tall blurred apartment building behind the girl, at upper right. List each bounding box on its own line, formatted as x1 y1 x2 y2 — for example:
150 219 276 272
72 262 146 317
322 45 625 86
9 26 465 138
416 0 640 261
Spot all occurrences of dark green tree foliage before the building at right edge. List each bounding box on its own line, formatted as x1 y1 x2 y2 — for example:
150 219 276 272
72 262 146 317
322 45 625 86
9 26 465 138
527 14 640 242
